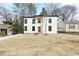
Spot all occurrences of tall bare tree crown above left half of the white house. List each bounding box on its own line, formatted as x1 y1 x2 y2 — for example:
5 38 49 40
14 3 36 16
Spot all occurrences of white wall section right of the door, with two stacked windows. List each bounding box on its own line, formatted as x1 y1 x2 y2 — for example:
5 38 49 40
43 17 57 34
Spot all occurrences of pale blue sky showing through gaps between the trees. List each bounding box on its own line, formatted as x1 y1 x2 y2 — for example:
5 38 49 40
0 3 79 14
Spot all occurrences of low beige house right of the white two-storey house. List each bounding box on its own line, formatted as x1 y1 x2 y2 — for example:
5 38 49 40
57 21 79 32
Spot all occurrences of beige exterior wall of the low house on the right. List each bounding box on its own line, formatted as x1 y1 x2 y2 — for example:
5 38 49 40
57 21 79 32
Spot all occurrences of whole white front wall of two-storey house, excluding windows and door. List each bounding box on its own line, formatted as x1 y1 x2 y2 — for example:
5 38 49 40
24 17 57 34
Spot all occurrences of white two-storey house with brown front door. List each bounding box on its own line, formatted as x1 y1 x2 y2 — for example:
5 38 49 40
24 15 57 34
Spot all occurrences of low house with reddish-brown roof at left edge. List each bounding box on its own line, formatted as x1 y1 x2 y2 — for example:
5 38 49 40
0 24 12 35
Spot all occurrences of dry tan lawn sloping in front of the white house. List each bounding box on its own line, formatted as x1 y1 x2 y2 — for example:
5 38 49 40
0 34 79 56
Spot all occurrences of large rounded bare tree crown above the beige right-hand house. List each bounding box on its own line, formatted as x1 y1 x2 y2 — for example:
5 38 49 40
60 5 77 21
